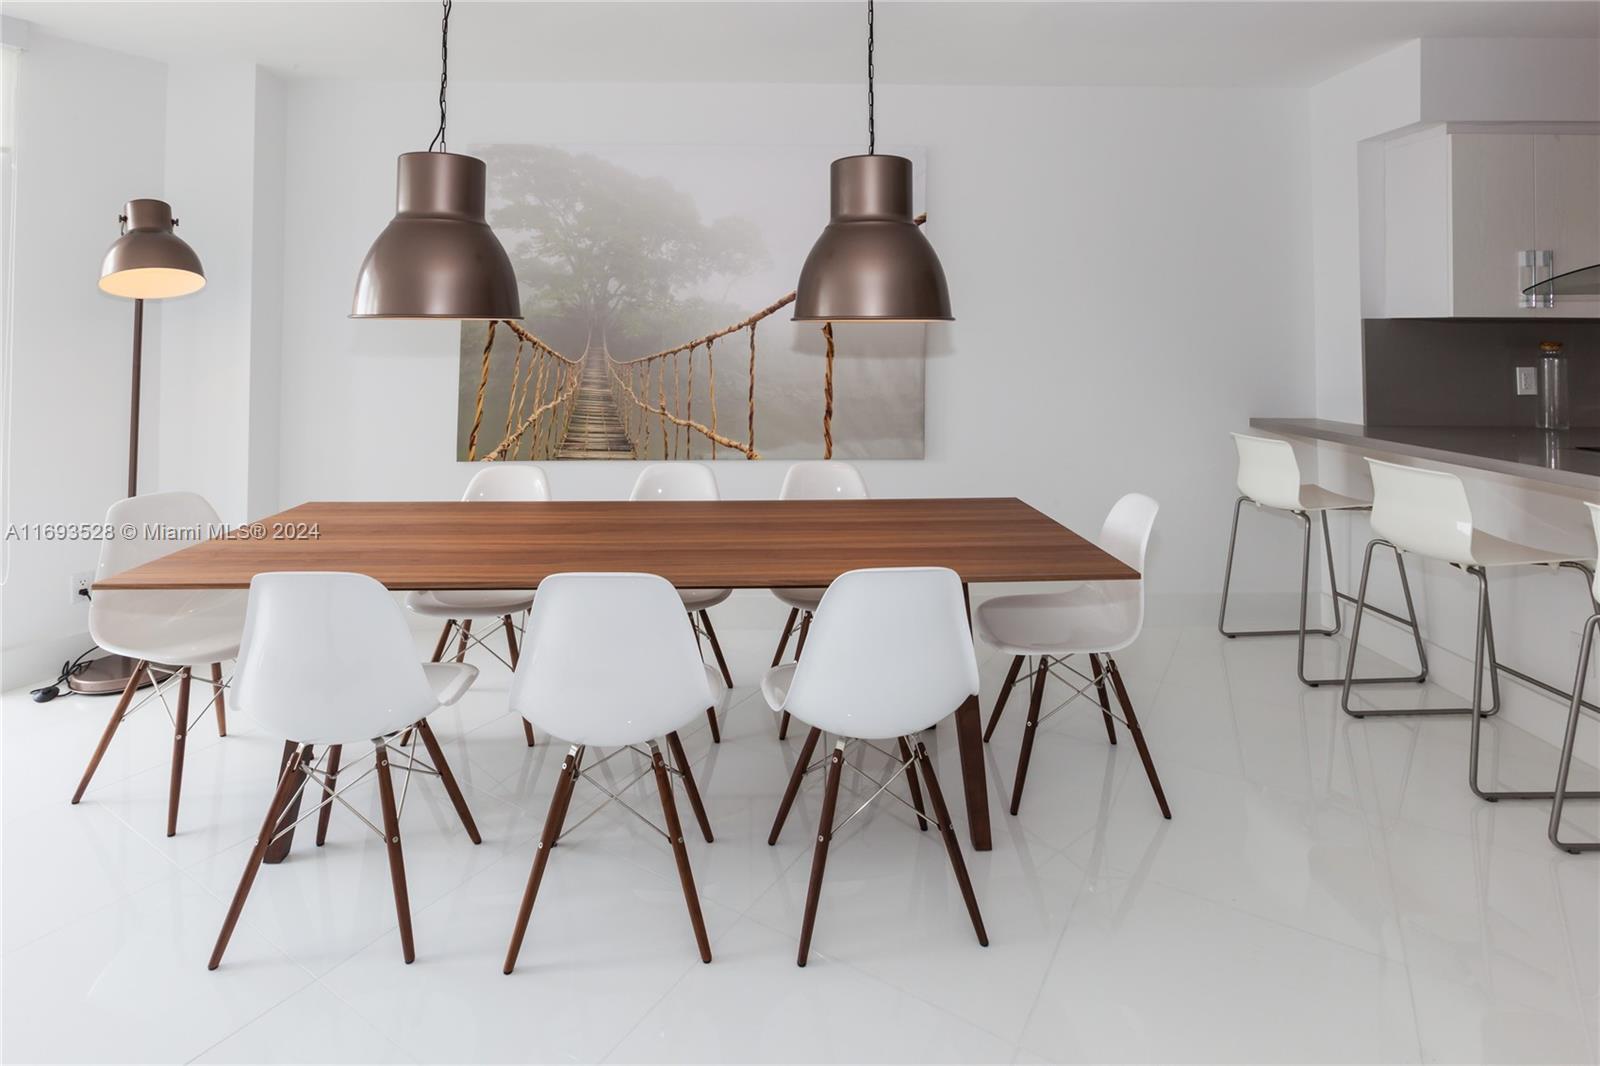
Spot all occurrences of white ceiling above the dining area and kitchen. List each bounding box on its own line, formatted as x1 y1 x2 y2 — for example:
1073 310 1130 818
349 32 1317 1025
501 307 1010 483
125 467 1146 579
5 0 1600 86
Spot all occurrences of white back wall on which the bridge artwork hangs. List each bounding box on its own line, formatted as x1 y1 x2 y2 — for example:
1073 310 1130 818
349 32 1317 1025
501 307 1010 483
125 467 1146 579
280 82 1314 616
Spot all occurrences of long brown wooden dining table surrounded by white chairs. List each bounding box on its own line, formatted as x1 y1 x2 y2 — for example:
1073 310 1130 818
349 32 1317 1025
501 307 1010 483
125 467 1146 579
94 498 1139 852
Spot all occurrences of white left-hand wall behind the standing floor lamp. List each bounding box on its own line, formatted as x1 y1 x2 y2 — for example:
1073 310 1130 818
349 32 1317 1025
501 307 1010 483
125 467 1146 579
0 30 167 688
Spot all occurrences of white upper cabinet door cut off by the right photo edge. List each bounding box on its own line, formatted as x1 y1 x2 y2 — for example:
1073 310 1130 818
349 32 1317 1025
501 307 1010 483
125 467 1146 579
1533 133 1600 308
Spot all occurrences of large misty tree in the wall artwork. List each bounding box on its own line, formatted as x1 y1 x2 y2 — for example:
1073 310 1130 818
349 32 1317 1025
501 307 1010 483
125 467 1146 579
482 144 766 355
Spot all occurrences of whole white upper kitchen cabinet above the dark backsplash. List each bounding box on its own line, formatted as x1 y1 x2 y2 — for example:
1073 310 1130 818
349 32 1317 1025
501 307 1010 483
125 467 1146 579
1382 126 1600 319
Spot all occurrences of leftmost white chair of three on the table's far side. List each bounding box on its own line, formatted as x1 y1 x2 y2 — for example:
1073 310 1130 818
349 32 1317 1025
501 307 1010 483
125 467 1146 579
405 463 550 747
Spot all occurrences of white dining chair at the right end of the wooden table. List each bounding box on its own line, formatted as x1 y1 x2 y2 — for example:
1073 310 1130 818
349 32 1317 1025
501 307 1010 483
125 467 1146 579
973 493 1173 818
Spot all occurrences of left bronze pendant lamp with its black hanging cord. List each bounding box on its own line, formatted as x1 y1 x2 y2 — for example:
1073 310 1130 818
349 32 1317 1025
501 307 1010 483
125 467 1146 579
350 0 522 319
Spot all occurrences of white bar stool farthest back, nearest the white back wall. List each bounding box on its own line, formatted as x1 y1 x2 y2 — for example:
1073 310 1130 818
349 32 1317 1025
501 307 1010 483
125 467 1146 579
1216 434 1427 688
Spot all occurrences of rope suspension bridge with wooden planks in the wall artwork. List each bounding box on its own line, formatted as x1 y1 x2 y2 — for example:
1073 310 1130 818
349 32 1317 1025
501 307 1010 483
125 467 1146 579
467 214 926 461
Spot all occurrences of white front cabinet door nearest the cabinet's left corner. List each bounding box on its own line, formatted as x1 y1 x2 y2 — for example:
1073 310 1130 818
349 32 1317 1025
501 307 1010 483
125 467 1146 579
1450 133 1544 315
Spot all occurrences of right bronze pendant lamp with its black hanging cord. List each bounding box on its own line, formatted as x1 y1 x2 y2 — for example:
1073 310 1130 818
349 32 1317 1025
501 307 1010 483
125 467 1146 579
794 0 954 322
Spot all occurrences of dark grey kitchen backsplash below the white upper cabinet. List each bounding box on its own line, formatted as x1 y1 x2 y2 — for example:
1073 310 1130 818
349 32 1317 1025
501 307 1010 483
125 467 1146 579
1362 319 1600 427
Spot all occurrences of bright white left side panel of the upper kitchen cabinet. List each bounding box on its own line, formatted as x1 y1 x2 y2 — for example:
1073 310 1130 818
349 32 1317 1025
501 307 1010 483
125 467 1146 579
1384 126 1451 319
